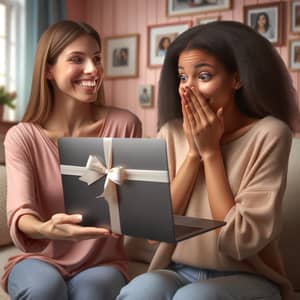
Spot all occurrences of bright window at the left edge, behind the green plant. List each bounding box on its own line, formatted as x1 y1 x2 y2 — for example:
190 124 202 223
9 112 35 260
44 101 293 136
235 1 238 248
0 0 24 120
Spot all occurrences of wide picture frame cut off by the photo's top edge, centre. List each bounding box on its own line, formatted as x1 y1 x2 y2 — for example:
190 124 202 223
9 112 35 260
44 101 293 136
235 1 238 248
166 0 232 16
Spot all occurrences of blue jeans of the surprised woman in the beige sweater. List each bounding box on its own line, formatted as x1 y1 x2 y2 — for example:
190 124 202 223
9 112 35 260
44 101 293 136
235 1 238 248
117 264 281 300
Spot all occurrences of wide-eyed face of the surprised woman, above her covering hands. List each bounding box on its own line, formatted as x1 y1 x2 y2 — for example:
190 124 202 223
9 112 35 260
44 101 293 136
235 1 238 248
178 49 240 112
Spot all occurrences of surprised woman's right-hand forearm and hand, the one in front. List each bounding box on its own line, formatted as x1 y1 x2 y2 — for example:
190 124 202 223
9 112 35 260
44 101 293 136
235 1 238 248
183 88 234 220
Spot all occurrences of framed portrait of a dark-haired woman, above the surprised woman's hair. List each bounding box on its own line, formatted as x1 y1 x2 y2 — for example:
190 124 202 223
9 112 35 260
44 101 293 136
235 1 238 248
244 2 283 46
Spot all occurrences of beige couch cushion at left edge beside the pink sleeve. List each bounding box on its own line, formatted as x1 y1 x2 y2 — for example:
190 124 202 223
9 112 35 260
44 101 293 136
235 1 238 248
0 165 11 246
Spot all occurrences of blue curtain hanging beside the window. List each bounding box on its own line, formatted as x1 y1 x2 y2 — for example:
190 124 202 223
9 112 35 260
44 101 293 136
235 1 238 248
16 0 66 120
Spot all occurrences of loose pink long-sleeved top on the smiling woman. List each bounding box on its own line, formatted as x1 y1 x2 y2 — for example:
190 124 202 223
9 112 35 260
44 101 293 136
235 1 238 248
1 108 141 288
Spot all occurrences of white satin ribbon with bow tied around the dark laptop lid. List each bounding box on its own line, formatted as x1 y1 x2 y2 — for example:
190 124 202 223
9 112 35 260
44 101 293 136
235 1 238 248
60 138 169 234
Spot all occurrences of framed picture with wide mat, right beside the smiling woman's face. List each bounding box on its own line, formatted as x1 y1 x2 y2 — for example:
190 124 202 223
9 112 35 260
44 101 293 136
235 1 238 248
104 34 139 79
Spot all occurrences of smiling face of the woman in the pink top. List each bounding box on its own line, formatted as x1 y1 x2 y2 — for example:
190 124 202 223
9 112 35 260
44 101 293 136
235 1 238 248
47 35 103 103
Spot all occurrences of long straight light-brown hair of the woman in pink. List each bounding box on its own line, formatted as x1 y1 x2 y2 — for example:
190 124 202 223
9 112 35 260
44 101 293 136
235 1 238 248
22 20 104 124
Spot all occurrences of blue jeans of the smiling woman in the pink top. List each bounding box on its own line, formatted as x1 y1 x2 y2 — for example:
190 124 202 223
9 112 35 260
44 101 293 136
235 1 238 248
8 259 126 300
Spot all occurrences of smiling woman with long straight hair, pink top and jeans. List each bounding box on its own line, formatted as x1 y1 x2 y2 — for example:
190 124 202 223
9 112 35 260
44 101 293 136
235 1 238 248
2 21 141 300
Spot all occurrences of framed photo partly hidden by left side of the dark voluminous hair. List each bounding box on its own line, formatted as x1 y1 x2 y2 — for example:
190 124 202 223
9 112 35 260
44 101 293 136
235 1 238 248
148 22 192 67
